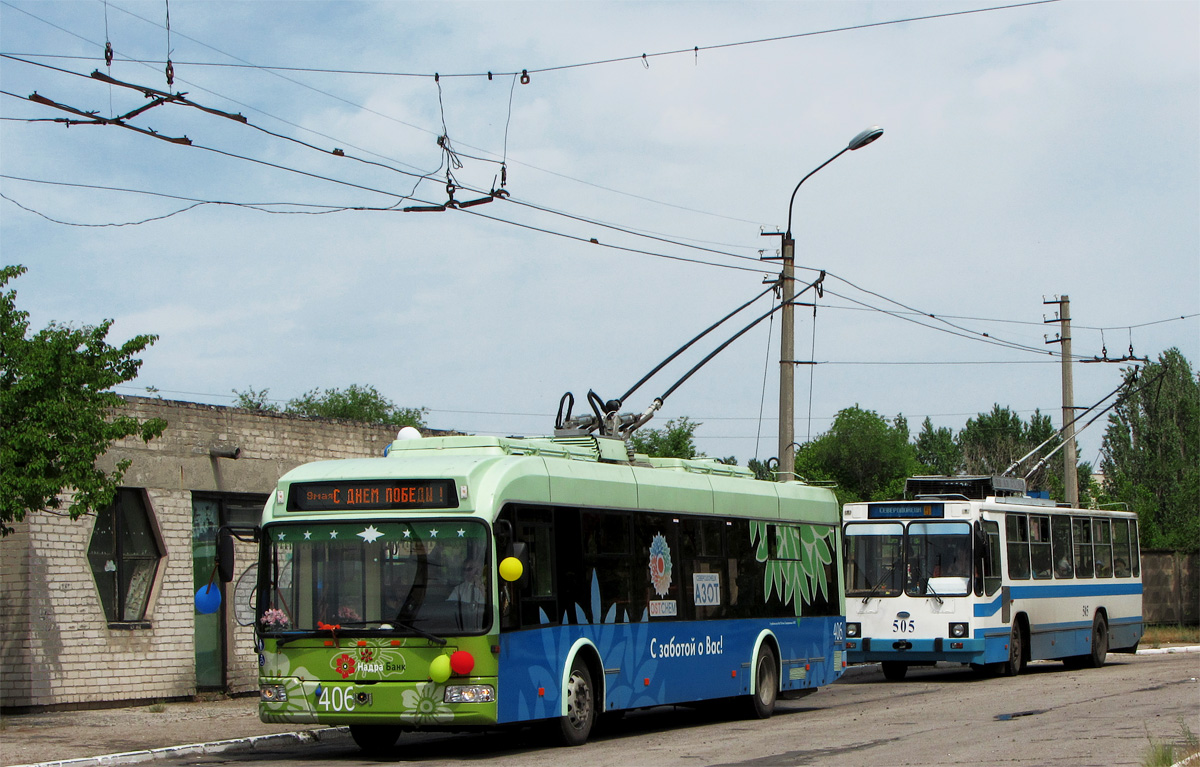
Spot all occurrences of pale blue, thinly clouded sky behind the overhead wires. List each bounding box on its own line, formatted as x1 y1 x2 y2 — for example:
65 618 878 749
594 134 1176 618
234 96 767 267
0 0 1200 463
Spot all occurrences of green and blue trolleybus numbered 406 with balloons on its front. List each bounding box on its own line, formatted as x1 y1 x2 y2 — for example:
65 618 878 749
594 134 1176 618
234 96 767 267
224 436 845 750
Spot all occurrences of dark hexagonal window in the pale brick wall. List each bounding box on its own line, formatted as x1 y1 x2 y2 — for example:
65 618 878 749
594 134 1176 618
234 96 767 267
88 487 162 624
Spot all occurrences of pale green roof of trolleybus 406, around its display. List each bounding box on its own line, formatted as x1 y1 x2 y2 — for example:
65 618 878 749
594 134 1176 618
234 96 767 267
263 436 840 525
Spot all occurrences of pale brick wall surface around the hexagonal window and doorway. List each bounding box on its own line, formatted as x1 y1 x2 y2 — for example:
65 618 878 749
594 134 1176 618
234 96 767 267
0 397 422 711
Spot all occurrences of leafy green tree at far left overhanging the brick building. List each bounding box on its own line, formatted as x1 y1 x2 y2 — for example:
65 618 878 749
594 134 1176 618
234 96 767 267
0 266 167 537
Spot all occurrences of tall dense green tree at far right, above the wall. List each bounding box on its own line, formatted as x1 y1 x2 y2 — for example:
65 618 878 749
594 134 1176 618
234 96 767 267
1100 348 1200 551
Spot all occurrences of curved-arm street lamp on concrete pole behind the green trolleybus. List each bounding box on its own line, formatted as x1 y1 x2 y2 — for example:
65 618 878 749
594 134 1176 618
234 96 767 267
779 125 883 483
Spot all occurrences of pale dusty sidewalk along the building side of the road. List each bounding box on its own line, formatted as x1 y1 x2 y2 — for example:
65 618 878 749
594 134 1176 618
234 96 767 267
0 646 1200 767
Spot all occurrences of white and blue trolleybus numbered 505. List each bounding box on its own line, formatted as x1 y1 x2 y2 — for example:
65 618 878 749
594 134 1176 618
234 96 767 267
842 477 1142 681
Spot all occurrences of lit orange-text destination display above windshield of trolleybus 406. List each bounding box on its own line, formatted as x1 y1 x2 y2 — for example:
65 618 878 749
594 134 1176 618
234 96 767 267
288 479 458 511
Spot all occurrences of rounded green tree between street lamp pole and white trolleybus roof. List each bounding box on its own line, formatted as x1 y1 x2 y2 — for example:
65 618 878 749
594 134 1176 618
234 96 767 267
796 405 919 503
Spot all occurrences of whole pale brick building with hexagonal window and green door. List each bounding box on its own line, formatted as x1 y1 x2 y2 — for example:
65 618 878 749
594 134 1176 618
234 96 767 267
0 397 420 712
